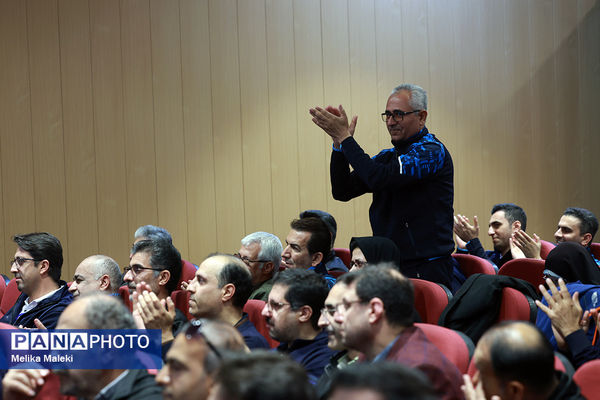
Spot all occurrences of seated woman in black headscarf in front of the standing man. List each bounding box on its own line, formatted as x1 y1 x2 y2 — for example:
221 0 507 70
349 236 402 271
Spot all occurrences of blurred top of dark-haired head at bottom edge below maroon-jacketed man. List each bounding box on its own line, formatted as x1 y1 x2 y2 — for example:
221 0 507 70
329 362 439 400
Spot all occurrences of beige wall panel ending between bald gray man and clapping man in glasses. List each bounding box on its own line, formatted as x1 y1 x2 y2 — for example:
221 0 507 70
90 0 131 265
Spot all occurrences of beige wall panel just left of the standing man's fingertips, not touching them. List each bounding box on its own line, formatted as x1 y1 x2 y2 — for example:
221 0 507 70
266 0 300 241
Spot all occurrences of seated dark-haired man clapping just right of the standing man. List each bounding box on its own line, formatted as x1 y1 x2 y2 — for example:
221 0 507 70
454 203 541 268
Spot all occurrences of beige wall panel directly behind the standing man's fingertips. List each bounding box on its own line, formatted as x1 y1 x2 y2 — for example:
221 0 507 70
290 0 331 212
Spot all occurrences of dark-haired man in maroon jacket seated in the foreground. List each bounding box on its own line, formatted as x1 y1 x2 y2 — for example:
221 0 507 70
334 265 462 399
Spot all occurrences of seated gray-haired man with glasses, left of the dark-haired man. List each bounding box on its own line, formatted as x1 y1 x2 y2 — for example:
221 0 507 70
236 232 283 302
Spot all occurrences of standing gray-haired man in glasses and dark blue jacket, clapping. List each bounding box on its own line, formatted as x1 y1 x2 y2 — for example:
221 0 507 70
310 84 454 286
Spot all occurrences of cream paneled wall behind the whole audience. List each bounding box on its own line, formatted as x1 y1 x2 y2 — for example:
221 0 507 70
0 0 600 279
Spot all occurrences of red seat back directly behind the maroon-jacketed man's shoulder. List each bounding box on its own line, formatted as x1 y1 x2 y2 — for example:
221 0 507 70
415 323 475 374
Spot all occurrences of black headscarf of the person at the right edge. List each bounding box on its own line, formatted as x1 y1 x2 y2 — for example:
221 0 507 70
545 242 600 285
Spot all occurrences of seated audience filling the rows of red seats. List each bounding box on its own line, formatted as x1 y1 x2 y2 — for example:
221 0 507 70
0 204 600 399
